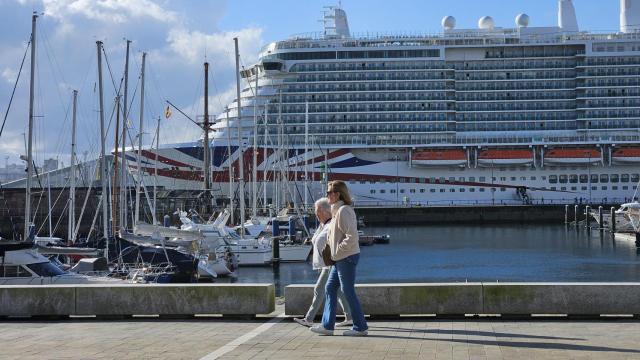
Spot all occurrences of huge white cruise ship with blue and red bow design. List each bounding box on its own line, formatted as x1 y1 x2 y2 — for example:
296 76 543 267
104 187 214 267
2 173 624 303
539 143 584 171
127 0 640 207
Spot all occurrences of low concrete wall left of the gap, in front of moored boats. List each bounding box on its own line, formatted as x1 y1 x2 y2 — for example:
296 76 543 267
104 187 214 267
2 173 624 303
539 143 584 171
0 284 275 316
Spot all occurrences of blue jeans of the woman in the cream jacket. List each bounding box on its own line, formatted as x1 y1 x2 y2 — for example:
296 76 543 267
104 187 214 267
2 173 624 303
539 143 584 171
322 254 369 331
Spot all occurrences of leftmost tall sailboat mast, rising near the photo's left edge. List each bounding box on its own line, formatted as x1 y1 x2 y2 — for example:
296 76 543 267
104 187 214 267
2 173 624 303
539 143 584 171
23 14 38 241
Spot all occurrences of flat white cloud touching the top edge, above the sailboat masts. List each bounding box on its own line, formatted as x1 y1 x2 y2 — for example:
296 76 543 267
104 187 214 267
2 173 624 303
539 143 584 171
42 0 178 24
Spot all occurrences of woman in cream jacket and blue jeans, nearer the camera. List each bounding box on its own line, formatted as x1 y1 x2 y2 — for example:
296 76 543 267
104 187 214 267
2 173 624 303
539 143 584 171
310 180 369 336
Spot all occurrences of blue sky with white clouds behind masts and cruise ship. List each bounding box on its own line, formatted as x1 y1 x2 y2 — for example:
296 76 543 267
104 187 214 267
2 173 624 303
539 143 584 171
0 0 619 168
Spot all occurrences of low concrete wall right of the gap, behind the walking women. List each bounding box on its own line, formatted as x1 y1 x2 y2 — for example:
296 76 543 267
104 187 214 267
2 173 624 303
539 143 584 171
285 283 640 316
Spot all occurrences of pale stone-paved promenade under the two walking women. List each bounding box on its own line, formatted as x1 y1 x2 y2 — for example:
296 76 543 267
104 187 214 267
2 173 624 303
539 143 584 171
0 306 640 360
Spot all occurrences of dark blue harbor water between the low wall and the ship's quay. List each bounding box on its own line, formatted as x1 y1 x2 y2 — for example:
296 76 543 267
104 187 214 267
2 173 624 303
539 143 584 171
221 225 640 294
